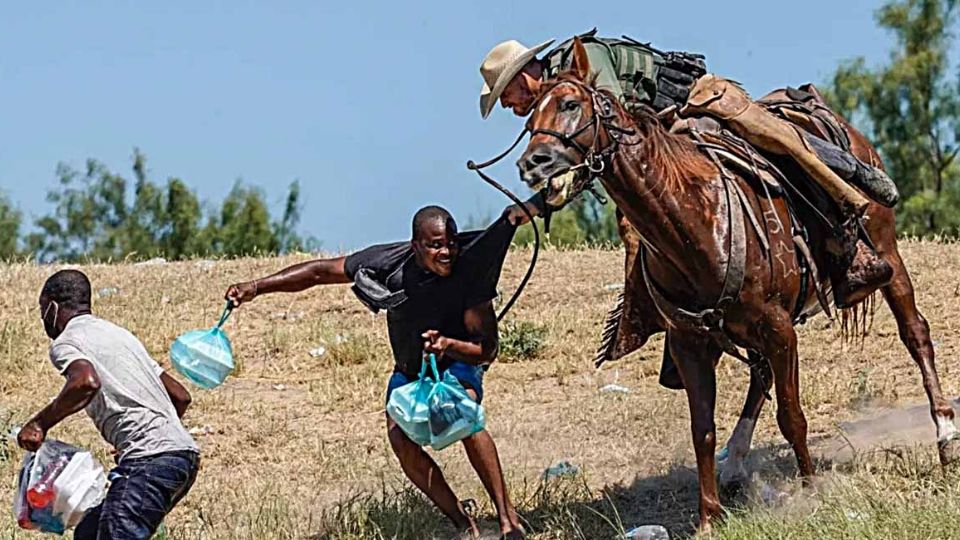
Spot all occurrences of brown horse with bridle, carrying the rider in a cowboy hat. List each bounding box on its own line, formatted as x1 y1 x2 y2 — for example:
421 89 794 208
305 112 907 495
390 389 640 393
518 42 960 529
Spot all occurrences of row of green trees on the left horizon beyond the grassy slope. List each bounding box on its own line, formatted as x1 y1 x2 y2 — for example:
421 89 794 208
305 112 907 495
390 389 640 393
26 149 315 260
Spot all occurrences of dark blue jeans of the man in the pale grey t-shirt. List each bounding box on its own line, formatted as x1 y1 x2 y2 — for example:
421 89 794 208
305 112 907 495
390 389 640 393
73 452 200 540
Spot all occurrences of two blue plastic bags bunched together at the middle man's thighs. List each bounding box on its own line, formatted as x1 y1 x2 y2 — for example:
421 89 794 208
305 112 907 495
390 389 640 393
387 354 486 450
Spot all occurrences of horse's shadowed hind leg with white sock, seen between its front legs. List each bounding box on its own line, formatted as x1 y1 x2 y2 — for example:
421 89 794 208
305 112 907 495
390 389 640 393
720 352 773 494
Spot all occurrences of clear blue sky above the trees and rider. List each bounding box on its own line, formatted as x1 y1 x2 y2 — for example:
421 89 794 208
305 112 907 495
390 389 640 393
0 0 891 250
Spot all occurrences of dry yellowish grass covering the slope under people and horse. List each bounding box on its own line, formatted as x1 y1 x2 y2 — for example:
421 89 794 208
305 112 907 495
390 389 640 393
0 242 960 539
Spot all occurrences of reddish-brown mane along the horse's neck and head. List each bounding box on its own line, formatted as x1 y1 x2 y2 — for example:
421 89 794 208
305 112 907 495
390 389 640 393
537 71 717 192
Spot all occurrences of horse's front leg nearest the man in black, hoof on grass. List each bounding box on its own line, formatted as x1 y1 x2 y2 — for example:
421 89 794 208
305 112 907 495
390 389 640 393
667 330 721 532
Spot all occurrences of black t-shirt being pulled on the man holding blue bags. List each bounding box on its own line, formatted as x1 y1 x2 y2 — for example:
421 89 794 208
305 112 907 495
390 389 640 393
344 217 517 377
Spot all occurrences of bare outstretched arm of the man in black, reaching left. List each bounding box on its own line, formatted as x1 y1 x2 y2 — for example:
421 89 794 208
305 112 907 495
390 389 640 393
224 257 352 306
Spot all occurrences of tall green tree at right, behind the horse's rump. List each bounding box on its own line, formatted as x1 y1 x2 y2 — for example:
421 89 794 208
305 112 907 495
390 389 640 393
829 0 960 236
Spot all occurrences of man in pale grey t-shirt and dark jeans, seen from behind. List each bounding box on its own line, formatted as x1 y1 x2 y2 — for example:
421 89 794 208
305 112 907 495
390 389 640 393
17 270 200 540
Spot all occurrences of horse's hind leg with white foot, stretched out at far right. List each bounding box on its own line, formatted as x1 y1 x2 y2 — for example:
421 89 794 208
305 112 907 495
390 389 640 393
878 244 960 465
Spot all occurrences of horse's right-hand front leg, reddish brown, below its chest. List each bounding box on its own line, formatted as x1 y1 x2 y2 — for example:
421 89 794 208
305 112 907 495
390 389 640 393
762 313 813 478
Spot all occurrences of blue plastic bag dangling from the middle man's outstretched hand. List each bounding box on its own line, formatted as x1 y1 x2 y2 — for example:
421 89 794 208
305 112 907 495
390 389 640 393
170 302 234 390
